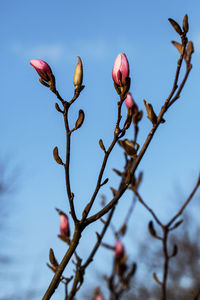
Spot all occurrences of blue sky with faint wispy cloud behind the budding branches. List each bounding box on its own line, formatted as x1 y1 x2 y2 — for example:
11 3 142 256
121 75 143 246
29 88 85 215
0 0 200 300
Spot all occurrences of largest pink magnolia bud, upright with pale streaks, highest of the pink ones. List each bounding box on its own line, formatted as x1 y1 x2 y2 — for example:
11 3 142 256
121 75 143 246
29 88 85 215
112 53 129 85
